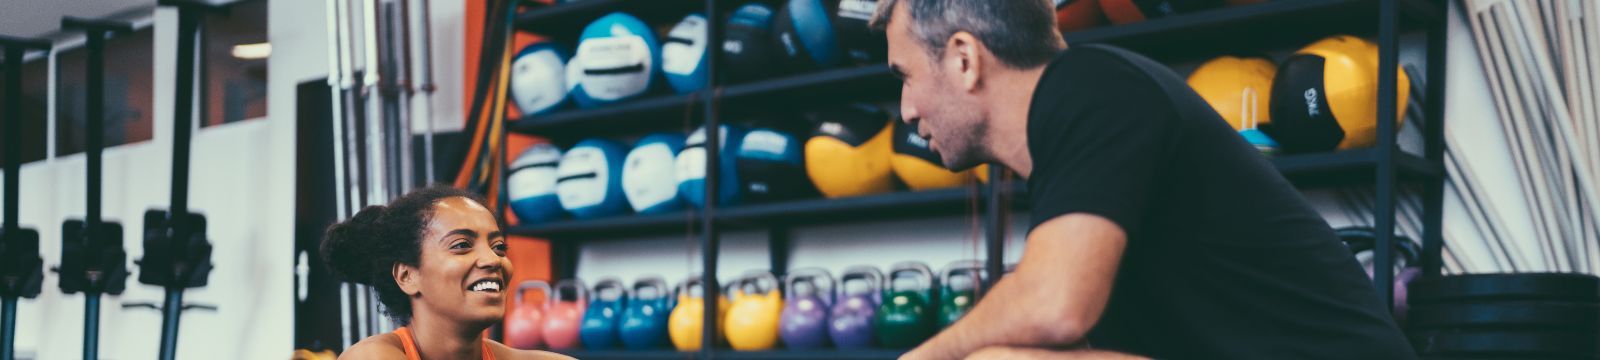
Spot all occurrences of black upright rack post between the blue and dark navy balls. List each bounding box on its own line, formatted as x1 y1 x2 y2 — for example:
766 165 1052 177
701 0 722 353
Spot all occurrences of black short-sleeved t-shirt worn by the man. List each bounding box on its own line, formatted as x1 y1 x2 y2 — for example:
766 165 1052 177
1027 45 1416 358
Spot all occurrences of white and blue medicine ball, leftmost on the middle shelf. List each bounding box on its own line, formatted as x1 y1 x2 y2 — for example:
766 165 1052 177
506 144 565 224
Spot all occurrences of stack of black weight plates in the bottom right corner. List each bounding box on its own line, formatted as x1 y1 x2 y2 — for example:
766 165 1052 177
1406 274 1600 360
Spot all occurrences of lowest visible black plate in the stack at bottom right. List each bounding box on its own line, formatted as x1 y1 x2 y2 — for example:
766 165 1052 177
1406 330 1600 358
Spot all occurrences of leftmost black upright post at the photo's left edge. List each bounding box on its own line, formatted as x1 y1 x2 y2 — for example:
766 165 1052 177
0 35 51 360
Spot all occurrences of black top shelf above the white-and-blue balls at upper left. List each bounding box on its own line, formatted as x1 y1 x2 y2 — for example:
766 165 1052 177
517 0 706 38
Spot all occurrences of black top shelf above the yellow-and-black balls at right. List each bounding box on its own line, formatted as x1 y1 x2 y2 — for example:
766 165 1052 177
1064 0 1443 61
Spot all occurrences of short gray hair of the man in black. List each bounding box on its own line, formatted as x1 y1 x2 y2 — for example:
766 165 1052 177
869 0 1062 69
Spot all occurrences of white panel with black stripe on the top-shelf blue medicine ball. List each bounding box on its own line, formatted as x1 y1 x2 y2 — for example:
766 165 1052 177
574 35 656 101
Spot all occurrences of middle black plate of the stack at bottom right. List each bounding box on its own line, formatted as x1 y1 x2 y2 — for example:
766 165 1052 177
1406 301 1600 334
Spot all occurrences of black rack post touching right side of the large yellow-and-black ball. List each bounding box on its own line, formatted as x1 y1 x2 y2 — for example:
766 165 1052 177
1373 0 1400 309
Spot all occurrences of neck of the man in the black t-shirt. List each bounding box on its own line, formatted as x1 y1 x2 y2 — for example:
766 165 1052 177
986 66 1045 179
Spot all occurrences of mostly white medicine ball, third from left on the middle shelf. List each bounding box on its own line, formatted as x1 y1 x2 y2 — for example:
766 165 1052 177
622 134 683 214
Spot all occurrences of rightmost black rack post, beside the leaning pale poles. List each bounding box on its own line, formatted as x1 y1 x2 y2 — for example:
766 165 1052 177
1422 3 1450 277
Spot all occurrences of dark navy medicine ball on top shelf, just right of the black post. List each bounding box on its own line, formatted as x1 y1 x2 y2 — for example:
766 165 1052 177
718 3 781 82
